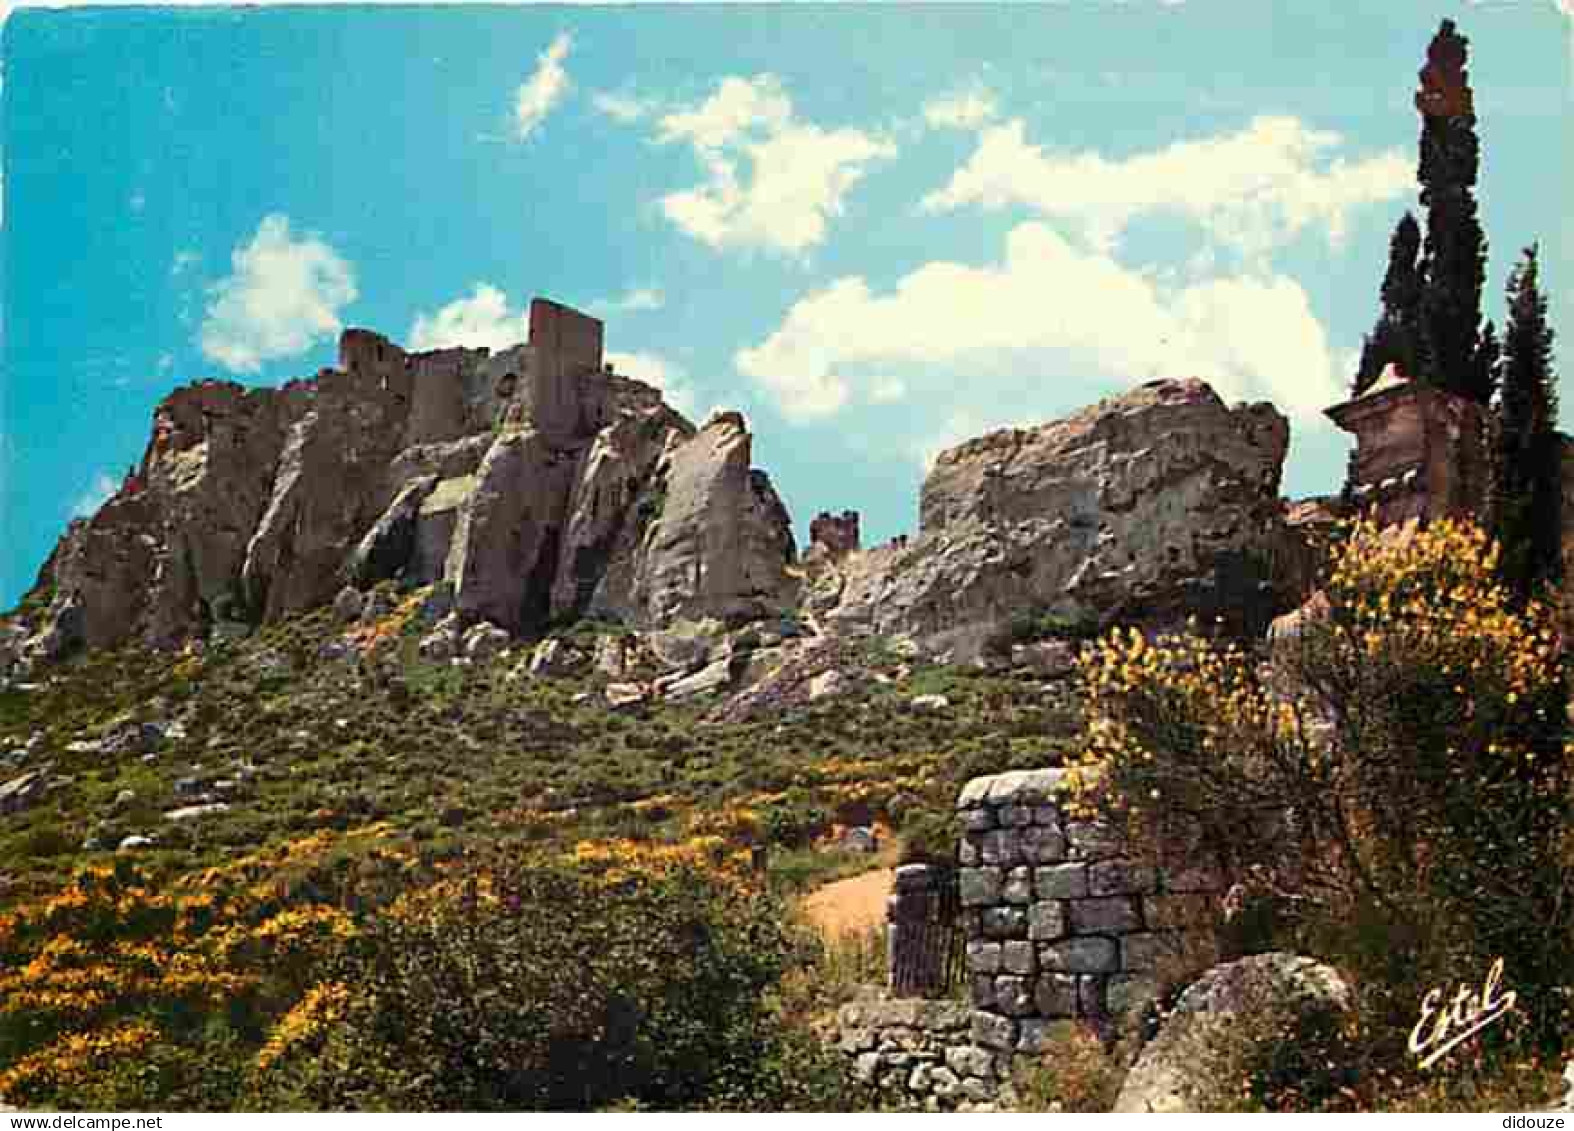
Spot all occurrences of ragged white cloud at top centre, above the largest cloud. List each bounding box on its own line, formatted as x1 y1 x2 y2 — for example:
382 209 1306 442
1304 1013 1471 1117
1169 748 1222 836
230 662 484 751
656 74 896 253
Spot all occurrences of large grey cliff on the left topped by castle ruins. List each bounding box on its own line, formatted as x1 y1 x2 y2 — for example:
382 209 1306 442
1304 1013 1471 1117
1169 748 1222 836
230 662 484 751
6 299 792 673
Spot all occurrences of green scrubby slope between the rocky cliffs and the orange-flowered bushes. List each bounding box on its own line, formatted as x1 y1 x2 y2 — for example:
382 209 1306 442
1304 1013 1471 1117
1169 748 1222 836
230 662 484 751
0 600 1073 898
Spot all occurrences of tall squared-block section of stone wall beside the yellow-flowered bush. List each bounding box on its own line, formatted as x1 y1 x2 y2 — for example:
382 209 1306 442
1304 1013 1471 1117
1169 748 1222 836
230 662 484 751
957 769 1223 1054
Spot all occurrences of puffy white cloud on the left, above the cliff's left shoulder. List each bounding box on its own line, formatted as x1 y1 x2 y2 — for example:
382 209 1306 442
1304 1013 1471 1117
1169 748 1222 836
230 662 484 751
198 212 356 373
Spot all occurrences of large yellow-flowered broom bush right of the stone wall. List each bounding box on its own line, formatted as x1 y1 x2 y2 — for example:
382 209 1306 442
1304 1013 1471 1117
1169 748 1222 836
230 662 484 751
1073 522 1574 1088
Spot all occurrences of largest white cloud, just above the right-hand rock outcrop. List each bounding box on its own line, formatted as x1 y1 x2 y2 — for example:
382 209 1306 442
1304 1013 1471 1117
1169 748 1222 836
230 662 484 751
735 222 1344 437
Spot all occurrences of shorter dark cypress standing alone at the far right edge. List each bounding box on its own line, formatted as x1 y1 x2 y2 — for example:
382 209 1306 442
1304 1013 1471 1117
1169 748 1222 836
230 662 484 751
1491 247 1563 598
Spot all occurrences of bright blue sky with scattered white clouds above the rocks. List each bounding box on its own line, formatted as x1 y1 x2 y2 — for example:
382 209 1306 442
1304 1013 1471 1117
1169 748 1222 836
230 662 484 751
0 0 1574 607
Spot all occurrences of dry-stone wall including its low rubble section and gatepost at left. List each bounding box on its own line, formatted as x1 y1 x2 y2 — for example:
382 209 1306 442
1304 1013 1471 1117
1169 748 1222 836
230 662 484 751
837 769 1225 1111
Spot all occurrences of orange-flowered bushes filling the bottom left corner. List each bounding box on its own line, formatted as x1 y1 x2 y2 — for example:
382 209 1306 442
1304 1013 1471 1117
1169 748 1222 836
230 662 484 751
0 853 354 1109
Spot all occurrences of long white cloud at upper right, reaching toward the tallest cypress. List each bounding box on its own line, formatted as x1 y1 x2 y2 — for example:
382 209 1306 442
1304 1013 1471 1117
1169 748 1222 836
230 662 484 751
922 116 1415 256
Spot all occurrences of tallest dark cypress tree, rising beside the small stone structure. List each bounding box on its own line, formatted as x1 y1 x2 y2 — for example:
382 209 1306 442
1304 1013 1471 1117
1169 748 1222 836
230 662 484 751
1415 19 1492 404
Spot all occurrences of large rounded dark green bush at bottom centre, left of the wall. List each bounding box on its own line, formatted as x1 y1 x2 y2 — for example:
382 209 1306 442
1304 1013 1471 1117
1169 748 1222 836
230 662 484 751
279 846 862 1111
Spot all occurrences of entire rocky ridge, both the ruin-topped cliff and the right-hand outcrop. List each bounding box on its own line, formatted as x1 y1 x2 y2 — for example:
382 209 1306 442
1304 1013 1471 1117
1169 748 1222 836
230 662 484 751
0 299 1305 682
